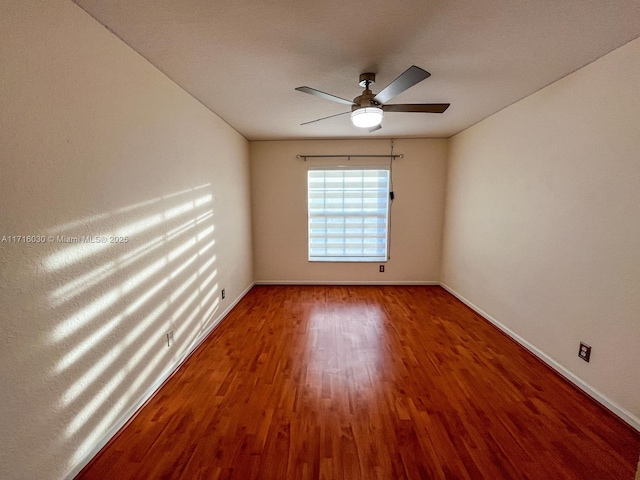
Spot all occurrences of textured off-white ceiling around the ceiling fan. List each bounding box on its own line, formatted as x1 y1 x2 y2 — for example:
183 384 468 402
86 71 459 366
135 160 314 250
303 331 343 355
75 0 640 140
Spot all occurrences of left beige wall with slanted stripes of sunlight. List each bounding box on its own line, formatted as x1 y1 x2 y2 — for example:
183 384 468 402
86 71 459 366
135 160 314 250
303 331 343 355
0 0 253 479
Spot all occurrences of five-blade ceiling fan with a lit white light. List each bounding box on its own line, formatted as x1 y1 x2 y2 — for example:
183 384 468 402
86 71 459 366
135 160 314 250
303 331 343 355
296 65 450 133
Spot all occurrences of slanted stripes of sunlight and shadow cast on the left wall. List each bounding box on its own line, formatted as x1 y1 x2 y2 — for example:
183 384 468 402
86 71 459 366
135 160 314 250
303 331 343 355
5 184 219 473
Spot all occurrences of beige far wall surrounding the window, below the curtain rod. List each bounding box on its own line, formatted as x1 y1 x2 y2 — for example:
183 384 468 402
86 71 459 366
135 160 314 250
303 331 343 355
250 139 447 283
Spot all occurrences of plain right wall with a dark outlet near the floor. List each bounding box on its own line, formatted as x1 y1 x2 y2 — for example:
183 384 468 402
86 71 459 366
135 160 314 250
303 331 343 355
442 40 640 428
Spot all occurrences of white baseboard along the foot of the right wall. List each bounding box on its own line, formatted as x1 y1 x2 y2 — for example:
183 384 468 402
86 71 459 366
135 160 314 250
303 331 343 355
440 283 640 432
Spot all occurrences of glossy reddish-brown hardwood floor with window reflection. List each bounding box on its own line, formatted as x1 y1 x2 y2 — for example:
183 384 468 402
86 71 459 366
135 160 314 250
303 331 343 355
77 286 640 480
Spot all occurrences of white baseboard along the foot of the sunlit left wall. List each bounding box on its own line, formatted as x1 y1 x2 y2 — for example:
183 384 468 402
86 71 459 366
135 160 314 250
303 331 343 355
62 283 254 480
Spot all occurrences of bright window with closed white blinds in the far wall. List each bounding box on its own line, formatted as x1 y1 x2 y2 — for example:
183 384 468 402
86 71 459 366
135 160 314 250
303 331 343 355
307 168 389 262
